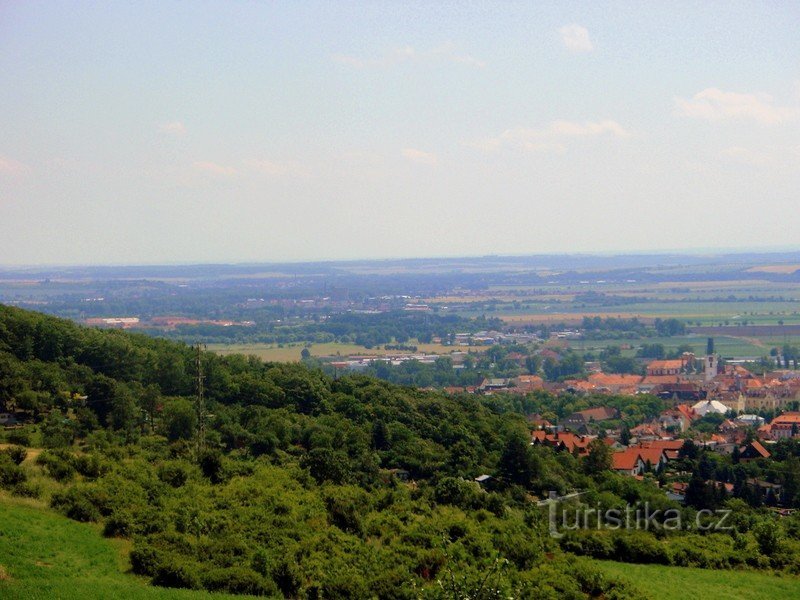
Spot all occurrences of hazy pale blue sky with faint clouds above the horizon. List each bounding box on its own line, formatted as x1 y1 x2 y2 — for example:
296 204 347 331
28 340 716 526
0 0 800 265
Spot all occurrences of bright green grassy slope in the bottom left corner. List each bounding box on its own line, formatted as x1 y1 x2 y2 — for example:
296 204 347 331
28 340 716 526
0 493 255 600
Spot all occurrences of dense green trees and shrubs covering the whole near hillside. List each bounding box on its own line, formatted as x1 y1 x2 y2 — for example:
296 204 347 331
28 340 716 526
0 306 800 598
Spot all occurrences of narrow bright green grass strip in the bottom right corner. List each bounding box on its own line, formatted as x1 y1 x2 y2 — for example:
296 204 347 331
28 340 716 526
592 561 800 600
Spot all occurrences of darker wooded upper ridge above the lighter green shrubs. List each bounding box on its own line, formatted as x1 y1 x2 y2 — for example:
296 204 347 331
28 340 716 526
0 307 526 478
